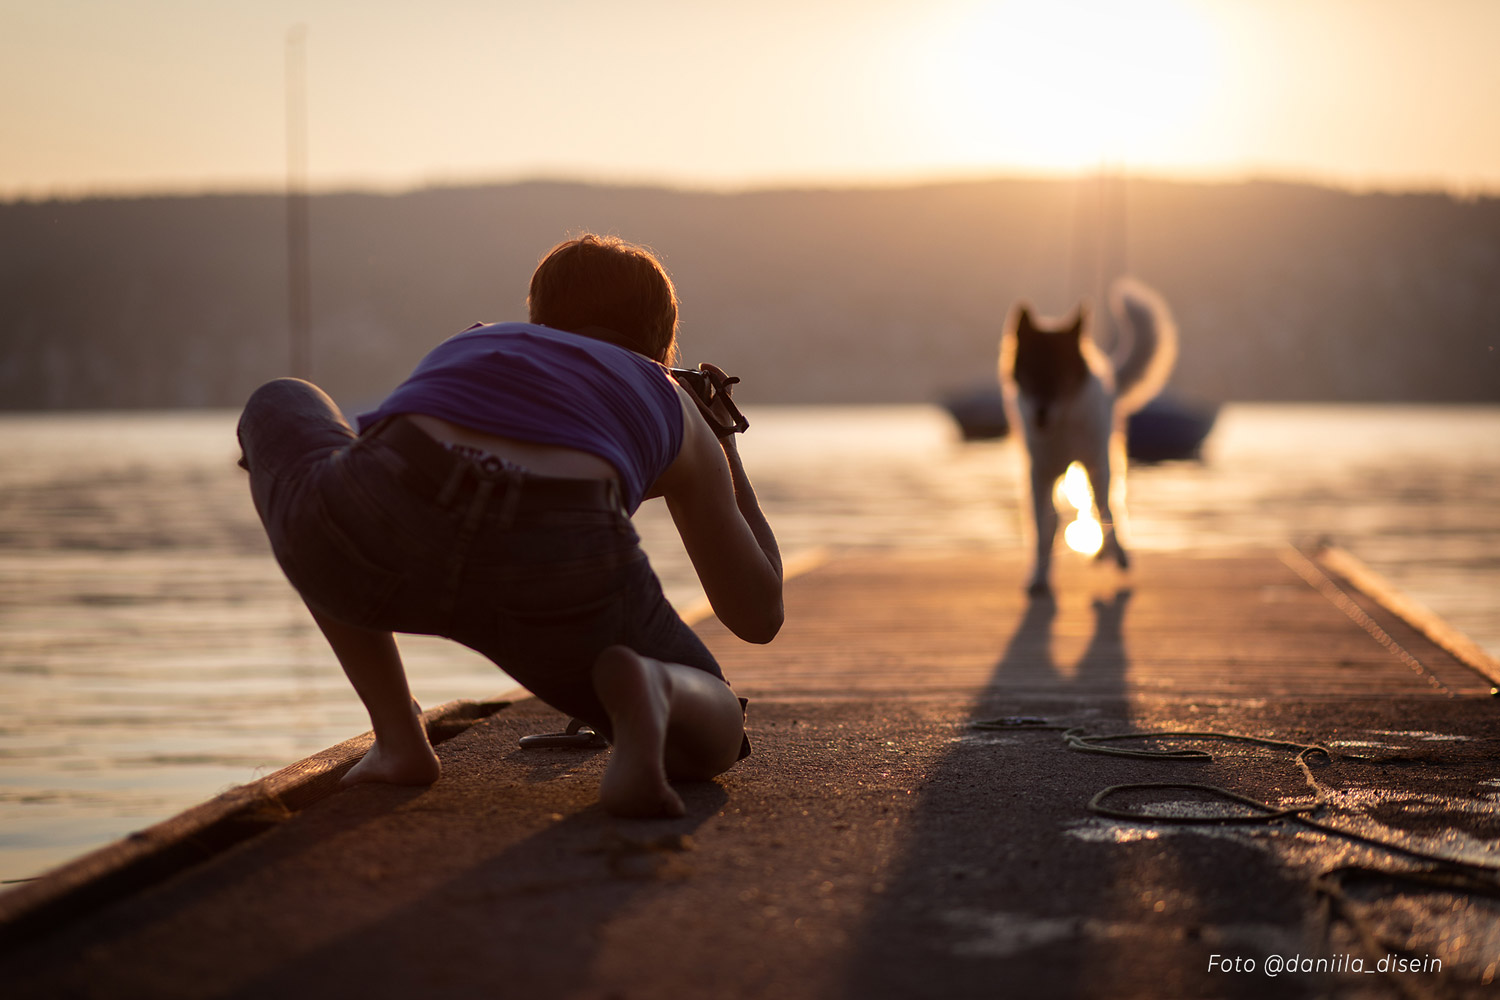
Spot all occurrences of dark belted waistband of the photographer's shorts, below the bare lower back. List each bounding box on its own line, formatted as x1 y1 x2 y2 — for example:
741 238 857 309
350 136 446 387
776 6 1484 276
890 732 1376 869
360 417 624 513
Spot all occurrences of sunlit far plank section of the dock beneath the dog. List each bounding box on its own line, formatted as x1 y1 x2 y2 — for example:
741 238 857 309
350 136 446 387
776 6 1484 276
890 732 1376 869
701 549 1491 699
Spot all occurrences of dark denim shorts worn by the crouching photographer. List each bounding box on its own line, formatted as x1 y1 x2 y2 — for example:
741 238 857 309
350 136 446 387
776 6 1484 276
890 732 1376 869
239 378 738 736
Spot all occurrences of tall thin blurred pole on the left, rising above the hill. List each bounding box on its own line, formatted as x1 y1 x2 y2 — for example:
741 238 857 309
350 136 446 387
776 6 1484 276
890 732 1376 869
287 24 312 378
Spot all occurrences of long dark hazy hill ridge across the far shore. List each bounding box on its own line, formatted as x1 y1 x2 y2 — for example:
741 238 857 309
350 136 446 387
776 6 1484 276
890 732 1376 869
0 180 1500 409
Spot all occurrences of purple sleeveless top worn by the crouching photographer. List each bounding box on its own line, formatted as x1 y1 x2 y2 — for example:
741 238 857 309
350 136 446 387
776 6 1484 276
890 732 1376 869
359 322 683 513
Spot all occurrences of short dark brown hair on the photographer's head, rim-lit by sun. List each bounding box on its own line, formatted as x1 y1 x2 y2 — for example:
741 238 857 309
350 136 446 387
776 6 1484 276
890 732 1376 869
527 232 677 364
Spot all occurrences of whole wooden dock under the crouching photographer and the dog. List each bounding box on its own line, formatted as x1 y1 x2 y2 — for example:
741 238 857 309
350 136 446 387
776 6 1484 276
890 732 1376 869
0 547 1500 1000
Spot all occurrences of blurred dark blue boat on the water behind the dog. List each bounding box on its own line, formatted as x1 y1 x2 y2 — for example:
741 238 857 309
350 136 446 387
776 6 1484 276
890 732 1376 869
942 385 1218 462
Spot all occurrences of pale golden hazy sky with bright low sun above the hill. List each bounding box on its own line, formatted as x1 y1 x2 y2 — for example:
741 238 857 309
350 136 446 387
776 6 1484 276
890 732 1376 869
0 0 1500 198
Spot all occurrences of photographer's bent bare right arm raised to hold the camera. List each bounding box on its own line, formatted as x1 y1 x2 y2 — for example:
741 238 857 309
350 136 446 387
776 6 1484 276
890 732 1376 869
657 388 785 643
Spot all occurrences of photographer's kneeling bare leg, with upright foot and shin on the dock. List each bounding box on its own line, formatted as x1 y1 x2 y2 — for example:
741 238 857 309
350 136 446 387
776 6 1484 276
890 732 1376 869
593 646 744 817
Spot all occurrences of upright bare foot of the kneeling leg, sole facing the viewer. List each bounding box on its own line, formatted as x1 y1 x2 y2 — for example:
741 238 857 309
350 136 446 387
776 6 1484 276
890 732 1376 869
594 646 687 817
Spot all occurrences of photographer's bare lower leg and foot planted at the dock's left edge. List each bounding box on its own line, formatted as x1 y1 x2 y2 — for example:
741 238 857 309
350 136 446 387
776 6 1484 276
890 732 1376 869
308 607 443 786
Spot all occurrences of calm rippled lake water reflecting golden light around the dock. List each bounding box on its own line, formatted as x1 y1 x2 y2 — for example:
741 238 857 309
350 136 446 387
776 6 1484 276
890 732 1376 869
0 405 1500 879
